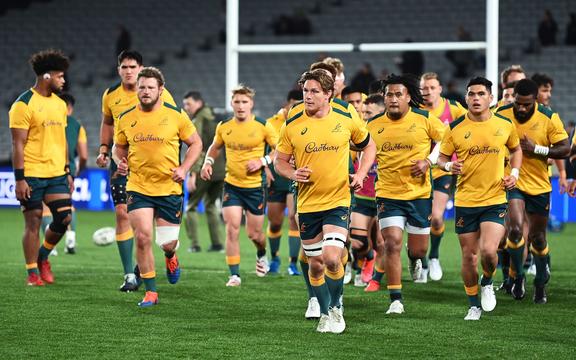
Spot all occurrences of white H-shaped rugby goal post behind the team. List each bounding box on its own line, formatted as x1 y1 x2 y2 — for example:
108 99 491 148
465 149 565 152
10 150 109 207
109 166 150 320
224 0 500 111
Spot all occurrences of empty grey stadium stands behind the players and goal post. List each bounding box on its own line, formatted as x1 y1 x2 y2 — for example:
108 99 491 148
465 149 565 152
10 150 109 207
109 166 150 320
0 0 576 164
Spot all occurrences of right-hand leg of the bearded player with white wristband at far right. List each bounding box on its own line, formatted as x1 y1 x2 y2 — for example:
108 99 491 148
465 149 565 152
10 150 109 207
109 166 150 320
526 193 550 304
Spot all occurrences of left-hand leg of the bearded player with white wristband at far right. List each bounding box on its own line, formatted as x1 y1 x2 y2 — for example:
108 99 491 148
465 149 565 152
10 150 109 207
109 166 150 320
506 194 526 300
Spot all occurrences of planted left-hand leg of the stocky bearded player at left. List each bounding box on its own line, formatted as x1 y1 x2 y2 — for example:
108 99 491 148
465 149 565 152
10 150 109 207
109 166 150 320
128 202 158 307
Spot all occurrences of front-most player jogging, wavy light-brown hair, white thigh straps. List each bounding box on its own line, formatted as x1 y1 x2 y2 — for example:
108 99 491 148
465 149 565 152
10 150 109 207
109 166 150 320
274 69 375 333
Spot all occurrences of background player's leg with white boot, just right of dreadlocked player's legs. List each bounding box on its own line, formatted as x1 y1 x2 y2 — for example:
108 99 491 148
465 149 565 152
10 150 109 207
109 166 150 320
428 187 451 281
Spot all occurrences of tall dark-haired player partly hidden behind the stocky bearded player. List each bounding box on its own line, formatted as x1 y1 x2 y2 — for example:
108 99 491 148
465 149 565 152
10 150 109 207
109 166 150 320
96 50 176 292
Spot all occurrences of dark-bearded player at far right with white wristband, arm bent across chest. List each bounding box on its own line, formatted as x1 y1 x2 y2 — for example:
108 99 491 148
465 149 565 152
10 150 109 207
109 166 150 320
497 79 570 304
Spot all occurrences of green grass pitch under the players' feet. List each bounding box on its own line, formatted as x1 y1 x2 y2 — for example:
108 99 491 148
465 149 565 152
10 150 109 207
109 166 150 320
0 209 576 359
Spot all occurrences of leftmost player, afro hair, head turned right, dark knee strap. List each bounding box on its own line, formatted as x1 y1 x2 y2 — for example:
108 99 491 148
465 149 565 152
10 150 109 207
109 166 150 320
9 50 73 286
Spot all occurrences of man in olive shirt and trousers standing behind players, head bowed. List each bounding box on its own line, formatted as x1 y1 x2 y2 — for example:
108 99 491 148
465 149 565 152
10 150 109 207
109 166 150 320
183 91 226 252
